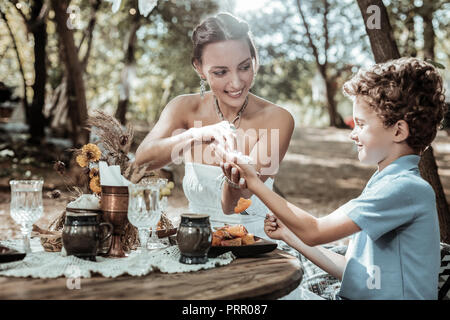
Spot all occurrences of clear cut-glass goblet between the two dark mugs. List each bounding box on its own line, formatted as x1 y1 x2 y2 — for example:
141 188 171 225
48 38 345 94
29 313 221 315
128 183 160 252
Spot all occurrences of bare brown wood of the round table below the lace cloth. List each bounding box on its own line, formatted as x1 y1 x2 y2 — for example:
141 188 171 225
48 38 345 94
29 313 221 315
0 249 303 300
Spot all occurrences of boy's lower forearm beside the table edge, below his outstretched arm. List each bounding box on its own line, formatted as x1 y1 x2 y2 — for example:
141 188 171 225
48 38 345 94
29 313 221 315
283 232 347 280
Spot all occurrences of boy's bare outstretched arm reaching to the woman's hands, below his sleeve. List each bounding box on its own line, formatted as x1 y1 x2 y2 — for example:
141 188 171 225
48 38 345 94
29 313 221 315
248 179 361 247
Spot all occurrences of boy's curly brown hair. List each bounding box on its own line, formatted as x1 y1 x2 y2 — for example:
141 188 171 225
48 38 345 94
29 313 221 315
343 58 446 153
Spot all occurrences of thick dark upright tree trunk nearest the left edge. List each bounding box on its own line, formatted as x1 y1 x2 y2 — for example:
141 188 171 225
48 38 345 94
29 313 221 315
28 0 47 144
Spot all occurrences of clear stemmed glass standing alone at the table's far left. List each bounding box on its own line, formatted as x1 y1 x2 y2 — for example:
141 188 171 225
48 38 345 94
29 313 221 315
9 180 44 252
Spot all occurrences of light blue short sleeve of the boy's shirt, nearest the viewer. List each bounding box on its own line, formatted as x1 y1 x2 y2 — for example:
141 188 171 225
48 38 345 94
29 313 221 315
340 178 430 241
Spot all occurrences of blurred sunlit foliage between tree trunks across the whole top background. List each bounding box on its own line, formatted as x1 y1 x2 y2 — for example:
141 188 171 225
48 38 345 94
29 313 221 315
0 0 450 131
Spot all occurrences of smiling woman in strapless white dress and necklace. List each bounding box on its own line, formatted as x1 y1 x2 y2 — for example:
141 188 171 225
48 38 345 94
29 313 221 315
136 13 294 237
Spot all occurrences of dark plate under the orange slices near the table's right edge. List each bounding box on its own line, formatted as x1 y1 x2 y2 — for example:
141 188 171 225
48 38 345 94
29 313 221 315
208 236 277 258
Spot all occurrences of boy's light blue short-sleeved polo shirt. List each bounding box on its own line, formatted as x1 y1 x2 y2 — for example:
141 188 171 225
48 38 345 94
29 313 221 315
338 155 440 300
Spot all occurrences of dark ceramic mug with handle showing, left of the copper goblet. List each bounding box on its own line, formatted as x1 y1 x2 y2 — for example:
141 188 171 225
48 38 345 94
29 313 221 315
62 212 113 261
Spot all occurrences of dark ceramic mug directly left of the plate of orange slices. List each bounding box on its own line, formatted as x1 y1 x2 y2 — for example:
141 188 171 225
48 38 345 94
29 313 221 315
177 214 212 264
